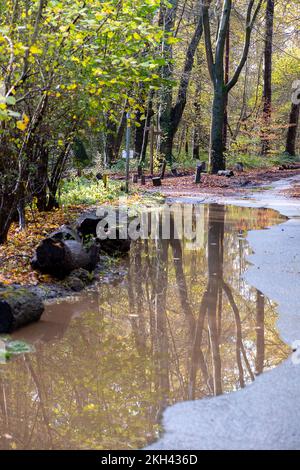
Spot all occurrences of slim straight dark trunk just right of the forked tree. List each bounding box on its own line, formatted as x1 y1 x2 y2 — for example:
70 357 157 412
261 0 275 155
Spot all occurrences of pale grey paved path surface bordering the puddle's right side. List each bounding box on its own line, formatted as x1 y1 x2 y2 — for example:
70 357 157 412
149 176 300 450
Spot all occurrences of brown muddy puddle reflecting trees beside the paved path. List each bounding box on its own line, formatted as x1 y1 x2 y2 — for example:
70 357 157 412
0 205 290 449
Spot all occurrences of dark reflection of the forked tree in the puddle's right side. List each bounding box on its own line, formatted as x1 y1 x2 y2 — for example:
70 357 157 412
189 205 264 399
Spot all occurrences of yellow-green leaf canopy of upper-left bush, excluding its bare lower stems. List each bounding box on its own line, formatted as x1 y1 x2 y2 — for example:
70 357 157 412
0 0 163 136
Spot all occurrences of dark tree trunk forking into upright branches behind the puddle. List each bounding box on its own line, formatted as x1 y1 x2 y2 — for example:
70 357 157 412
203 0 263 173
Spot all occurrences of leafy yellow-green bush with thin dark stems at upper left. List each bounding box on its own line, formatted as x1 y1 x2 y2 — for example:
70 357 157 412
0 0 163 242
